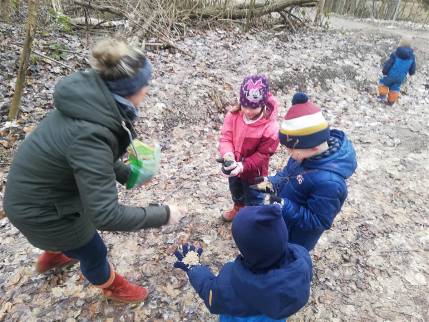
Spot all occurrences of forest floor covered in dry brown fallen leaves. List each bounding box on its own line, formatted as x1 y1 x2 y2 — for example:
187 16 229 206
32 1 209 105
0 14 429 322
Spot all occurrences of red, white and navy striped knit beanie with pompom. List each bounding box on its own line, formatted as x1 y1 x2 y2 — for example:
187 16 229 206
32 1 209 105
279 93 330 149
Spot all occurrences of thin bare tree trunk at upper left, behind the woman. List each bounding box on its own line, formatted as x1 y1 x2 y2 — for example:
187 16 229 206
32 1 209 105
8 0 39 121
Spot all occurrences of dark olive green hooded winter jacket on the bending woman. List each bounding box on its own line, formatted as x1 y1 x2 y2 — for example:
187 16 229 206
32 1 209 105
4 70 169 251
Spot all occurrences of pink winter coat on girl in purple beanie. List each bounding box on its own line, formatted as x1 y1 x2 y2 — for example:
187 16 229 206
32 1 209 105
219 93 279 184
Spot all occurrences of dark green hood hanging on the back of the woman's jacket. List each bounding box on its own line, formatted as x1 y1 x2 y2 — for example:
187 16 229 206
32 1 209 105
54 70 123 133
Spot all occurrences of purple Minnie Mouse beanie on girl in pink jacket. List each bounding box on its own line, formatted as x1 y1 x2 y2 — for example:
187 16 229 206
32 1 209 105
240 75 270 108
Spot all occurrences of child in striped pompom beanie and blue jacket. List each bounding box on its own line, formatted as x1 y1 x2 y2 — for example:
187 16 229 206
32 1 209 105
253 93 357 251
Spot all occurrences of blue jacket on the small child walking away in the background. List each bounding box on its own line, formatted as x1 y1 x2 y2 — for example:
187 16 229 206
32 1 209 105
383 47 416 83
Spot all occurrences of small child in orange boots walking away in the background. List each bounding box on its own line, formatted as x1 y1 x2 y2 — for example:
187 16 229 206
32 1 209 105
378 37 416 105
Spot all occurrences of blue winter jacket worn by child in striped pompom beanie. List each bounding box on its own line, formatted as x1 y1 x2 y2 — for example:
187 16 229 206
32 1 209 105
268 130 357 251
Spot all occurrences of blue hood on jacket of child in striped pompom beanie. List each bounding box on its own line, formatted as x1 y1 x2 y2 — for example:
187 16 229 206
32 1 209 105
303 130 357 179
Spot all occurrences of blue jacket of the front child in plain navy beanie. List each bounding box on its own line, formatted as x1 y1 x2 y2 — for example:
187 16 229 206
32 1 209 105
188 244 313 321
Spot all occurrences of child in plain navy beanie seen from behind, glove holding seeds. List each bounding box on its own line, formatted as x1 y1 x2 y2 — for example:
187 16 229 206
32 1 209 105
174 204 312 322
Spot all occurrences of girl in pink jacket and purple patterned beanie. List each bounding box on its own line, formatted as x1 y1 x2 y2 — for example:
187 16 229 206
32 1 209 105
219 75 279 221
